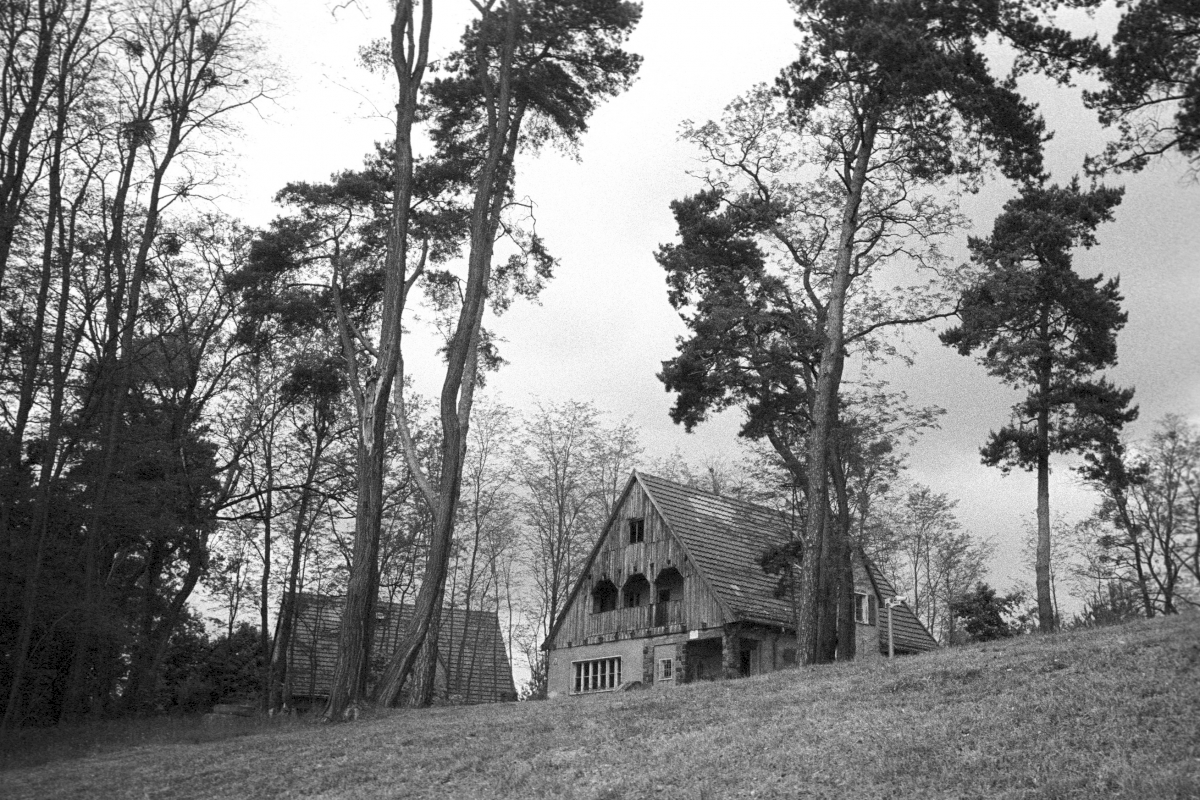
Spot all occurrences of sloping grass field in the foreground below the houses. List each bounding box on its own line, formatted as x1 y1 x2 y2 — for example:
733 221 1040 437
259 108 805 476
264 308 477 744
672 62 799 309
0 614 1200 800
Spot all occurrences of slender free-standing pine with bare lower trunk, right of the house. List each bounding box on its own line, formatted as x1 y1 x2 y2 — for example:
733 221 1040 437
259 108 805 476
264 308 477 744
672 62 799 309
942 181 1138 631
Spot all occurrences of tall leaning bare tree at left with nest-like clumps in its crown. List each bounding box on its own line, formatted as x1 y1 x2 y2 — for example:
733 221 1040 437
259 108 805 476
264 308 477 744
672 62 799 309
55 0 265 716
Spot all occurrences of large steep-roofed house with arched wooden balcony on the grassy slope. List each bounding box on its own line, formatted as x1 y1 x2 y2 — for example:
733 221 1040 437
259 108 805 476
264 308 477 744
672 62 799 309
542 471 937 697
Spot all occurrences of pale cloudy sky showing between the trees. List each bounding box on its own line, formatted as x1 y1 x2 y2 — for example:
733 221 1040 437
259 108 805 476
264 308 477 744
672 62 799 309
224 0 1200 599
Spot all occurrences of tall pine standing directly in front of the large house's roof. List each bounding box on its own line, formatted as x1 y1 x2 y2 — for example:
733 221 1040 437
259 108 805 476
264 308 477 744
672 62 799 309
660 0 1043 662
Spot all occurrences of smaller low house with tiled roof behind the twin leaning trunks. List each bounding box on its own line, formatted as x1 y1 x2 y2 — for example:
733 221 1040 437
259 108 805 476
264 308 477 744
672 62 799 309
290 593 517 705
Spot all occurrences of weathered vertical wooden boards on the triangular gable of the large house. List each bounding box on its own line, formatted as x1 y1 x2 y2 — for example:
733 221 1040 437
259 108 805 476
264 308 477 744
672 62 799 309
550 483 725 648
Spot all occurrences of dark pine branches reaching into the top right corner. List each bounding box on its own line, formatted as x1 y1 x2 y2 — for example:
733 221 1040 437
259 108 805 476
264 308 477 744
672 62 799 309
1084 0 1200 173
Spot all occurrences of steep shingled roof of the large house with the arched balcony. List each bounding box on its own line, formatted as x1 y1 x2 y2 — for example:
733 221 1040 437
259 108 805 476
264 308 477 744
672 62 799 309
634 471 937 652
